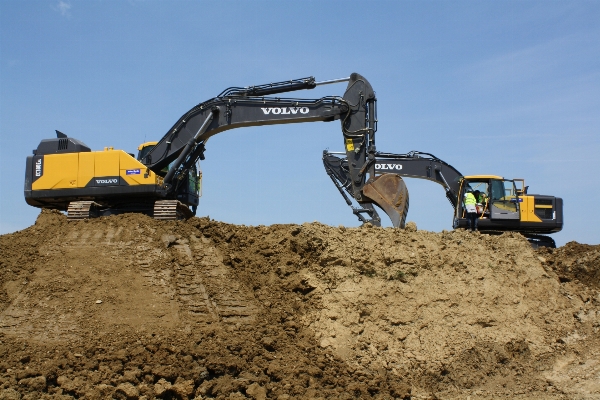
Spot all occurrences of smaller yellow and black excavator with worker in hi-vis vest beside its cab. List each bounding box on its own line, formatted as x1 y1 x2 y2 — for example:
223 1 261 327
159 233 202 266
323 151 563 247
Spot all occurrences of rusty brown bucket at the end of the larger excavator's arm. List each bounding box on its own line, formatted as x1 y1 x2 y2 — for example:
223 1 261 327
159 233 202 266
363 174 408 229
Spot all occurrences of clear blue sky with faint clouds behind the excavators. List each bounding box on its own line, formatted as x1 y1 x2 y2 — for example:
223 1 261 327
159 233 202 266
0 0 600 245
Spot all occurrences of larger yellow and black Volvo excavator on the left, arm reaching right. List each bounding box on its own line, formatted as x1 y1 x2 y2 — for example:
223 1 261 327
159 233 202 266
25 73 406 224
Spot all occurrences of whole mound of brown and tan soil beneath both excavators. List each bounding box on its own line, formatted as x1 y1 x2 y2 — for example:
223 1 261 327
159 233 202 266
0 211 600 400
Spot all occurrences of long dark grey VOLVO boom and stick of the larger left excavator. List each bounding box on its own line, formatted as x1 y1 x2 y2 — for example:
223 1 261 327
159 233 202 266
142 73 386 225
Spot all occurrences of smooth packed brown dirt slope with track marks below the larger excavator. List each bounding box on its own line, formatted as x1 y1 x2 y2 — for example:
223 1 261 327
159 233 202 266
0 217 258 341
